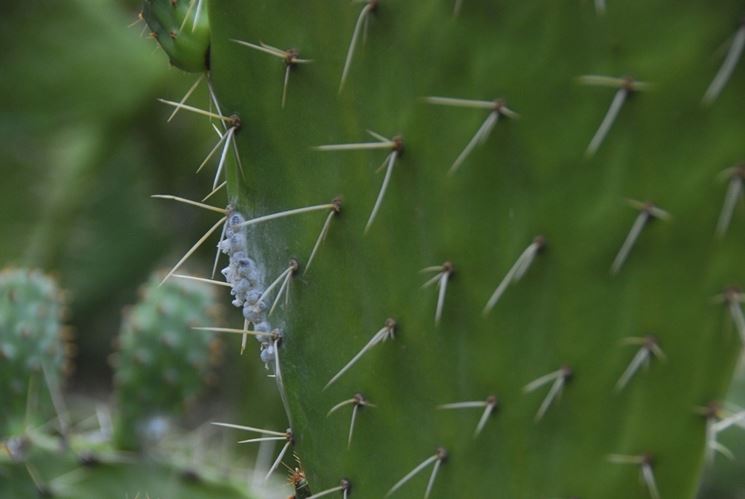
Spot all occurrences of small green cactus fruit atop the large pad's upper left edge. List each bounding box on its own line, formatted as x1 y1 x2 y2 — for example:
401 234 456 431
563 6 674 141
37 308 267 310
142 0 210 73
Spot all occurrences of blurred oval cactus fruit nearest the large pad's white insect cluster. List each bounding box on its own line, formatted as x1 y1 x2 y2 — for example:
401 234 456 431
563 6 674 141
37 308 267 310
114 276 219 448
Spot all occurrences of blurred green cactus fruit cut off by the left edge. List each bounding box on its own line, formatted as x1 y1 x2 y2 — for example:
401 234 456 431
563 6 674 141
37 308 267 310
0 269 70 436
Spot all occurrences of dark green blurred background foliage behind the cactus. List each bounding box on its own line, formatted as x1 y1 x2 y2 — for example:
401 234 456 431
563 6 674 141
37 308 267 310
0 0 745 499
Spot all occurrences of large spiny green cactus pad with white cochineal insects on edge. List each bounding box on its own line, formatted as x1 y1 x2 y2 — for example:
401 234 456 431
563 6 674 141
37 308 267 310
151 0 745 499
